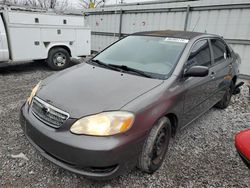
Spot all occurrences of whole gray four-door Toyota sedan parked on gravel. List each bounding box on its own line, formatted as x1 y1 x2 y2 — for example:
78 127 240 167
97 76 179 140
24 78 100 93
20 31 239 179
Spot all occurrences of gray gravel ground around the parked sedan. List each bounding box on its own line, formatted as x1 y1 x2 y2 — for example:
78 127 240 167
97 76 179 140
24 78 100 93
0 63 250 188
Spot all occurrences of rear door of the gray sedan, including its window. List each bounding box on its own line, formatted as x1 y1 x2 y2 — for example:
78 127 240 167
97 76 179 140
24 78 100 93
210 38 233 104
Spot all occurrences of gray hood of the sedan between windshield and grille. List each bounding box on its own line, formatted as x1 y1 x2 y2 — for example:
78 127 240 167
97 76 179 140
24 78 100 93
37 64 163 118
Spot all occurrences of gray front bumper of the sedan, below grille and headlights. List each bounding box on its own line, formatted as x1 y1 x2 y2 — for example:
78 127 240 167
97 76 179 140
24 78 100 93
20 104 145 179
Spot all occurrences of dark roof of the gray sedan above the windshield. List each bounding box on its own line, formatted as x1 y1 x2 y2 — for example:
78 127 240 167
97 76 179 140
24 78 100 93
132 30 217 39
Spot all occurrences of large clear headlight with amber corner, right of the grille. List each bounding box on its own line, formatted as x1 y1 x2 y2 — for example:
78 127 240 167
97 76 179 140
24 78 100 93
70 111 134 136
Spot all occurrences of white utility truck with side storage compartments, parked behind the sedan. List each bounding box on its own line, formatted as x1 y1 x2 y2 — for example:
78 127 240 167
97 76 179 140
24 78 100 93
0 6 91 70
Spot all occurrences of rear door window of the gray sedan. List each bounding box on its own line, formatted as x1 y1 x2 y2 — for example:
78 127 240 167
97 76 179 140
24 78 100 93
211 39 231 64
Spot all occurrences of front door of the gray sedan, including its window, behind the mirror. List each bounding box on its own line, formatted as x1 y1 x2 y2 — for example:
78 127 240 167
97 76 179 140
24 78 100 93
184 39 214 124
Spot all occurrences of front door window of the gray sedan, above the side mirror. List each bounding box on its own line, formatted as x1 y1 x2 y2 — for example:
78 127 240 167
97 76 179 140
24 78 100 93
186 40 211 69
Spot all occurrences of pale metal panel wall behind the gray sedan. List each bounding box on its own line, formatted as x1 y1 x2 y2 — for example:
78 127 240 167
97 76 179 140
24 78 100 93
87 0 250 75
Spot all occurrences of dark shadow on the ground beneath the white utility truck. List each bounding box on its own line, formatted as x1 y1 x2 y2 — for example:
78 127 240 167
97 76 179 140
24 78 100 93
0 61 53 75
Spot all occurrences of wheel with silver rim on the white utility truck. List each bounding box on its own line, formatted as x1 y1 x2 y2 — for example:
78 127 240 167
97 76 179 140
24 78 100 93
47 48 70 70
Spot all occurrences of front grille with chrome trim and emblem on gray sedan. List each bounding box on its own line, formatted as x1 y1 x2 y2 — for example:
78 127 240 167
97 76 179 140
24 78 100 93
32 97 69 128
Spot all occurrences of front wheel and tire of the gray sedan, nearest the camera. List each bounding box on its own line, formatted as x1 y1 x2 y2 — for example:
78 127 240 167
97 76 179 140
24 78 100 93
137 117 171 174
